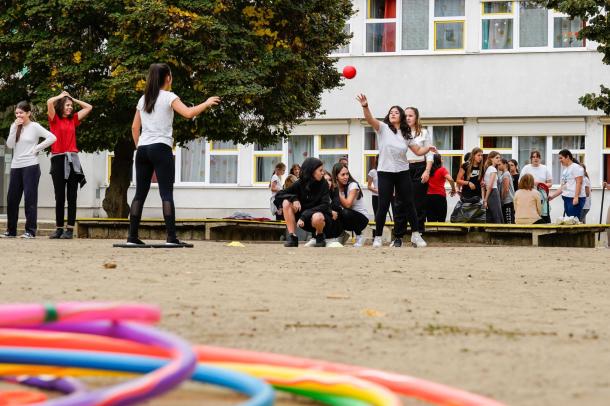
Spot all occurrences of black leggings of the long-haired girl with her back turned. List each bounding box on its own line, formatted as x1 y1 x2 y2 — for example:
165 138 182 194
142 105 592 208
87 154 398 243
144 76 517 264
129 143 176 241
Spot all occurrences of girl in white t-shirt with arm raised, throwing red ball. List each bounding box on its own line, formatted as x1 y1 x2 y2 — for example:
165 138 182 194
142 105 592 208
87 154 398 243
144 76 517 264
356 94 436 247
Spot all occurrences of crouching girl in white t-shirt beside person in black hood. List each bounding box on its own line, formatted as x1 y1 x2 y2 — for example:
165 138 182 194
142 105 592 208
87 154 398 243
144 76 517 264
332 163 369 248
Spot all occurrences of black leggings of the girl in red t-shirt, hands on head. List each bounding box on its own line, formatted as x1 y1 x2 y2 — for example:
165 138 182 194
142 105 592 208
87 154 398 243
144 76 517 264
51 155 78 227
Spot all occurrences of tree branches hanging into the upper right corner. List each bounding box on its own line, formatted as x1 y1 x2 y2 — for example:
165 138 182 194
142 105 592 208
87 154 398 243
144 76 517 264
535 0 610 115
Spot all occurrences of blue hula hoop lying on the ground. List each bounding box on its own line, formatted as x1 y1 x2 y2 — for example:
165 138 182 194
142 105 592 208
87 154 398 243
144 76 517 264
0 347 275 406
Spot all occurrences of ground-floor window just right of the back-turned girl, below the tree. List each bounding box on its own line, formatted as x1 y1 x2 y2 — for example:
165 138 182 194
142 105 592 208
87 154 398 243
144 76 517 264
180 139 238 184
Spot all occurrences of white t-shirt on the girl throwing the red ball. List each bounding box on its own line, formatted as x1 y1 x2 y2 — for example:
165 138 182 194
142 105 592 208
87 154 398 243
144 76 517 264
377 122 413 173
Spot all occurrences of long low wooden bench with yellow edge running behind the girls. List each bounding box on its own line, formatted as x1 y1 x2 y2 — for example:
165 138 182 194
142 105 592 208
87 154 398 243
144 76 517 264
77 218 610 248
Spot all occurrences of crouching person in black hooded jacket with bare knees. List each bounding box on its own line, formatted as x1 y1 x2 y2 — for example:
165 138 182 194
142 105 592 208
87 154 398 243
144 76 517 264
275 158 332 247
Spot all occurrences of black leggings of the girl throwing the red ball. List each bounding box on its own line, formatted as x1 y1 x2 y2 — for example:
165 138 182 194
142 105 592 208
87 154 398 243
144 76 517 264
375 171 417 238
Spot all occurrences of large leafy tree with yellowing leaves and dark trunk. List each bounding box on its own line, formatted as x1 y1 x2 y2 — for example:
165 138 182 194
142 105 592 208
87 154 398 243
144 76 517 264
0 0 353 217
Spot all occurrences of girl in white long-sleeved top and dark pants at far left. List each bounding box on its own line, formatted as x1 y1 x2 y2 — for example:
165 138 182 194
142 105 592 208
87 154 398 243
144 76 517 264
2 101 56 238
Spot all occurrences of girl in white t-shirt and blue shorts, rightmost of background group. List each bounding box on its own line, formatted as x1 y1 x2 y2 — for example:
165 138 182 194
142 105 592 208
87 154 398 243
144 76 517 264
549 149 586 218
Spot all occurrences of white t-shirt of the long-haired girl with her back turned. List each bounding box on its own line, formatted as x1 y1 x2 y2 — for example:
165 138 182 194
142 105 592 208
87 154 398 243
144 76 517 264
137 90 178 147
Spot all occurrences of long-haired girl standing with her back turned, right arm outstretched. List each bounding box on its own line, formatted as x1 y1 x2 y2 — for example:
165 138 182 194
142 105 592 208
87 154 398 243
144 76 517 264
127 63 220 245
